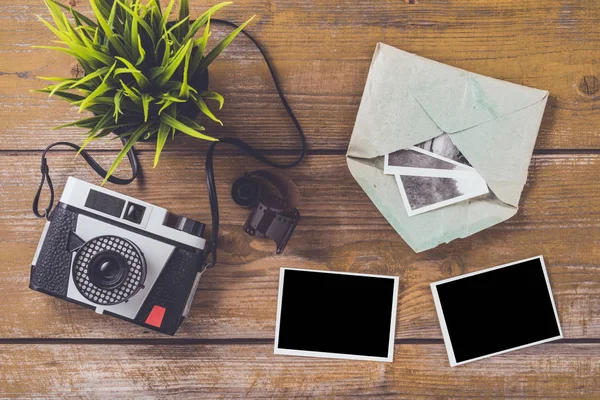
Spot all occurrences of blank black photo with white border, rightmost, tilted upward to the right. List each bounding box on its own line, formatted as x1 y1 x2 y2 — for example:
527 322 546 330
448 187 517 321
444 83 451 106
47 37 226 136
431 256 562 366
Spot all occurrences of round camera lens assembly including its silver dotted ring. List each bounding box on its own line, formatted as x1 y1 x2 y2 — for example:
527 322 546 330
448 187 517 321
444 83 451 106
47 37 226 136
71 235 146 306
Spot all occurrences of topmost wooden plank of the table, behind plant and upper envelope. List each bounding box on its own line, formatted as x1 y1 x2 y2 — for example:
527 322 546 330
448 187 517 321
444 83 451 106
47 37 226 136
0 0 600 151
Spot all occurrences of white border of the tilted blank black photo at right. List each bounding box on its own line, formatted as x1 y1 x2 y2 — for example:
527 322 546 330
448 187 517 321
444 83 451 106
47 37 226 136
430 255 563 367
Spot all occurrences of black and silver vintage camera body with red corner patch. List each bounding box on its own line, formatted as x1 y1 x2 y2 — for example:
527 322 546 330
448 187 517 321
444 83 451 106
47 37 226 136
29 177 206 335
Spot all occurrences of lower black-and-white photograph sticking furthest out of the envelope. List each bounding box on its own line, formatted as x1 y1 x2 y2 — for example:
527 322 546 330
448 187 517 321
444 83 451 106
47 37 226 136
395 174 489 216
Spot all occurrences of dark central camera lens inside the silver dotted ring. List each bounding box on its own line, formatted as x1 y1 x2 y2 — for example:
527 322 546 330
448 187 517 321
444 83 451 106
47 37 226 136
88 250 129 290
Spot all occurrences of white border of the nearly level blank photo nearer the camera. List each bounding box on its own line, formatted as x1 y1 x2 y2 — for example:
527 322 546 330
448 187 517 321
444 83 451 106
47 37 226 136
273 268 400 362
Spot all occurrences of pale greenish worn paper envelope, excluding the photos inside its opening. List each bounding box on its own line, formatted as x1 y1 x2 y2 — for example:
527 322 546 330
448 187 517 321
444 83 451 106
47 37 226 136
346 43 548 252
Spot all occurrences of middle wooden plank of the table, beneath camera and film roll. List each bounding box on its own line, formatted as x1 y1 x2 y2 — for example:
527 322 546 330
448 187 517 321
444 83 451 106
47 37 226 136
0 152 600 339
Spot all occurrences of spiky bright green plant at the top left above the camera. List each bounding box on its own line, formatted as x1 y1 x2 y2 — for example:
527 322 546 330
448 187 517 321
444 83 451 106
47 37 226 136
35 0 254 182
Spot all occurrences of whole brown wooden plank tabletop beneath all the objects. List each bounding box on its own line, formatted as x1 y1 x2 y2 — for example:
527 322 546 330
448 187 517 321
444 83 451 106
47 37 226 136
0 0 600 399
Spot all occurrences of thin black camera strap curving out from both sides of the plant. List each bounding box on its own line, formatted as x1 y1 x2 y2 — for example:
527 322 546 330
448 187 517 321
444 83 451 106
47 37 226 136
33 19 306 268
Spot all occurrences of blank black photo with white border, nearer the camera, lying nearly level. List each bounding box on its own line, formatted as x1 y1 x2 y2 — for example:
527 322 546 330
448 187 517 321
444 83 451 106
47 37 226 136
275 268 398 362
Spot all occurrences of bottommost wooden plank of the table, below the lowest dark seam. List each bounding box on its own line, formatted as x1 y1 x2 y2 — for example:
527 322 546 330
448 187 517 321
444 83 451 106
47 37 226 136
0 344 600 399
